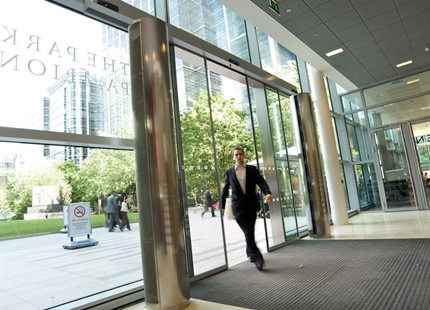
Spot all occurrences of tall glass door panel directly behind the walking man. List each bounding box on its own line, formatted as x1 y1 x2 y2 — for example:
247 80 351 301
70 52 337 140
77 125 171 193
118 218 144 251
207 61 267 266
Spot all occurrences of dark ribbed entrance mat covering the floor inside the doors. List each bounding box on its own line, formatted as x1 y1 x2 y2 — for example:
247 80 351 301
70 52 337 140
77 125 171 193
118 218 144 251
190 239 430 310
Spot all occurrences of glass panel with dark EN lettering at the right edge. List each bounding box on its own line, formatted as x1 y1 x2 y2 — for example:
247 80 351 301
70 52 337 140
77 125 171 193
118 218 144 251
412 120 430 207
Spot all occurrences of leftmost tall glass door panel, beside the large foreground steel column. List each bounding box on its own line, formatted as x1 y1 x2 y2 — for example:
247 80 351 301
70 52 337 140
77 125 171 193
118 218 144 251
175 48 226 275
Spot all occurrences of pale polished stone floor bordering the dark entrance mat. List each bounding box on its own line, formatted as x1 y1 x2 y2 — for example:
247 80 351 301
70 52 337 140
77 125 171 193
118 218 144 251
124 210 430 310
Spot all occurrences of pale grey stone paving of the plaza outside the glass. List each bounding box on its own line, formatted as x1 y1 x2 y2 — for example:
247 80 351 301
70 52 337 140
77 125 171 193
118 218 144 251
0 209 270 310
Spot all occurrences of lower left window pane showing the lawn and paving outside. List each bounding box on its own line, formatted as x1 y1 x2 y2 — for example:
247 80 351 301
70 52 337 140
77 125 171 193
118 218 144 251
0 143 138 309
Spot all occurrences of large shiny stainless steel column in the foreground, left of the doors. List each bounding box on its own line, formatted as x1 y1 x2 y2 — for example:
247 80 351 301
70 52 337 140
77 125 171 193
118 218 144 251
129 17 190 310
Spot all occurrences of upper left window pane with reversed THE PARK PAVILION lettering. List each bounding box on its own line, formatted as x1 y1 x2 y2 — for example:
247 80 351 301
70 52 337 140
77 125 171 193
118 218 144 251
0 0 131 138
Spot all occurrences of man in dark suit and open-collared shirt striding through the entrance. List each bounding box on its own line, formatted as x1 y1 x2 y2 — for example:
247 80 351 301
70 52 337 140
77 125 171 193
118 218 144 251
221 147 273 270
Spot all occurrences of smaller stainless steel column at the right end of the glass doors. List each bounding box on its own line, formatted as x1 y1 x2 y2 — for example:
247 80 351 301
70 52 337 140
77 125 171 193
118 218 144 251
294 93 331 238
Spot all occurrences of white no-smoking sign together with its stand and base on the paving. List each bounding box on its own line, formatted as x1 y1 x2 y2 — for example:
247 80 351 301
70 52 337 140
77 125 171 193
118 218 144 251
63 202 99 249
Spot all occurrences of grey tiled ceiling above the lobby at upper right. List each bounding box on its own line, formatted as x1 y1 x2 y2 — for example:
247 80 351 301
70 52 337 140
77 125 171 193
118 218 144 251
245 0 430 88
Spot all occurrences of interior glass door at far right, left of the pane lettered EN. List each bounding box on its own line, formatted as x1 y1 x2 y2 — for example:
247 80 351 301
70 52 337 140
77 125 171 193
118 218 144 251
374 127 416 210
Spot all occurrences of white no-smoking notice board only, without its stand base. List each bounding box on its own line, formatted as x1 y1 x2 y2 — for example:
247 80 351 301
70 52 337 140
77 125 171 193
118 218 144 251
67 202 91 237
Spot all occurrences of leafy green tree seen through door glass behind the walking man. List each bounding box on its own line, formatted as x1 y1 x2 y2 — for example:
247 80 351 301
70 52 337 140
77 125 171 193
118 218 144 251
181 90 254 203
